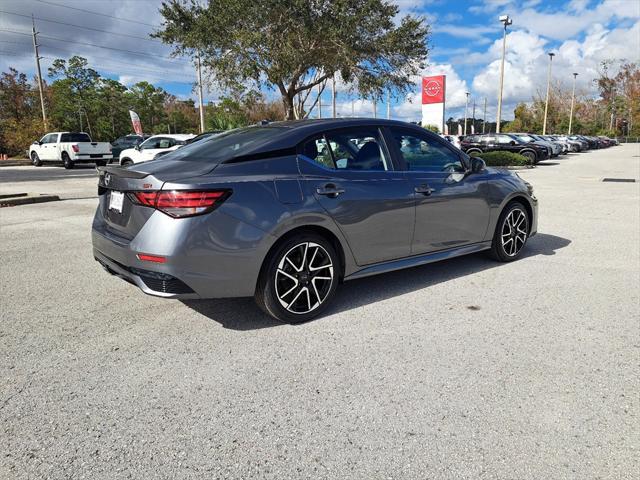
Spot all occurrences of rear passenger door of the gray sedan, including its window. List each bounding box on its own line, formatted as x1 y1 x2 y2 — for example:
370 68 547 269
298 127 415 265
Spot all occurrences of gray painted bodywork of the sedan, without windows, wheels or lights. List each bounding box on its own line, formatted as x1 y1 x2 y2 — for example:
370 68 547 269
92 120 537 298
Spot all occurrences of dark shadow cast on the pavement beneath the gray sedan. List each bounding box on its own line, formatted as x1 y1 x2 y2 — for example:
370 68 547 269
182 233 571 330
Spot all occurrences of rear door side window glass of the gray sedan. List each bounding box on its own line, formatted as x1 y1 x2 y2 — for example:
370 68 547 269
300 128 391 170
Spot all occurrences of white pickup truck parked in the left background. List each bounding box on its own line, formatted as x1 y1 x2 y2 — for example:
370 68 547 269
29 132 113 168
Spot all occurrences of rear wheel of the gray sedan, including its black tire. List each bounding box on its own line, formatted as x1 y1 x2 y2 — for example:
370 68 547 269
254 233 341 323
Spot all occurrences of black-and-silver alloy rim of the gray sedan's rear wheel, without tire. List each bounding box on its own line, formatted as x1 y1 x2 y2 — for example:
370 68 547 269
275 242 334 315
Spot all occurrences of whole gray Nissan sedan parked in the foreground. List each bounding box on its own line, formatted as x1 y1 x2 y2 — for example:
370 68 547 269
92 119 538 322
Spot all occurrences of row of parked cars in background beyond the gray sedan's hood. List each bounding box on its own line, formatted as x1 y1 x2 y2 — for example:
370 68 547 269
452 133 618 164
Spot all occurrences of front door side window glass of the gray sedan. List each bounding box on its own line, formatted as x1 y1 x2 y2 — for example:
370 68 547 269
391 129 465 173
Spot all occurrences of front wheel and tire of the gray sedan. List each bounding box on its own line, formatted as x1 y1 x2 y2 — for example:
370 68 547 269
490 201 531 262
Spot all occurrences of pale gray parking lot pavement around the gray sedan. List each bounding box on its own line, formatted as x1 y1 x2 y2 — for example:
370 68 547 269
0 145 640 479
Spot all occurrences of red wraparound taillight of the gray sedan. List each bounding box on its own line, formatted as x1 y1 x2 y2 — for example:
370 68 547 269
130 190 231 218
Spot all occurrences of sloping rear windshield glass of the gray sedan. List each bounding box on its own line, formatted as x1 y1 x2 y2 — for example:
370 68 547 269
154 127 286 164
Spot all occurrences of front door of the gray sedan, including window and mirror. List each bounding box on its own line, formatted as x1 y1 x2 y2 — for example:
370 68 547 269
389 127 490 255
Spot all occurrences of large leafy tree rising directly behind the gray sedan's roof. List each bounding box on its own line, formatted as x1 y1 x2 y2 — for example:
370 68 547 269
155 0 429 119
